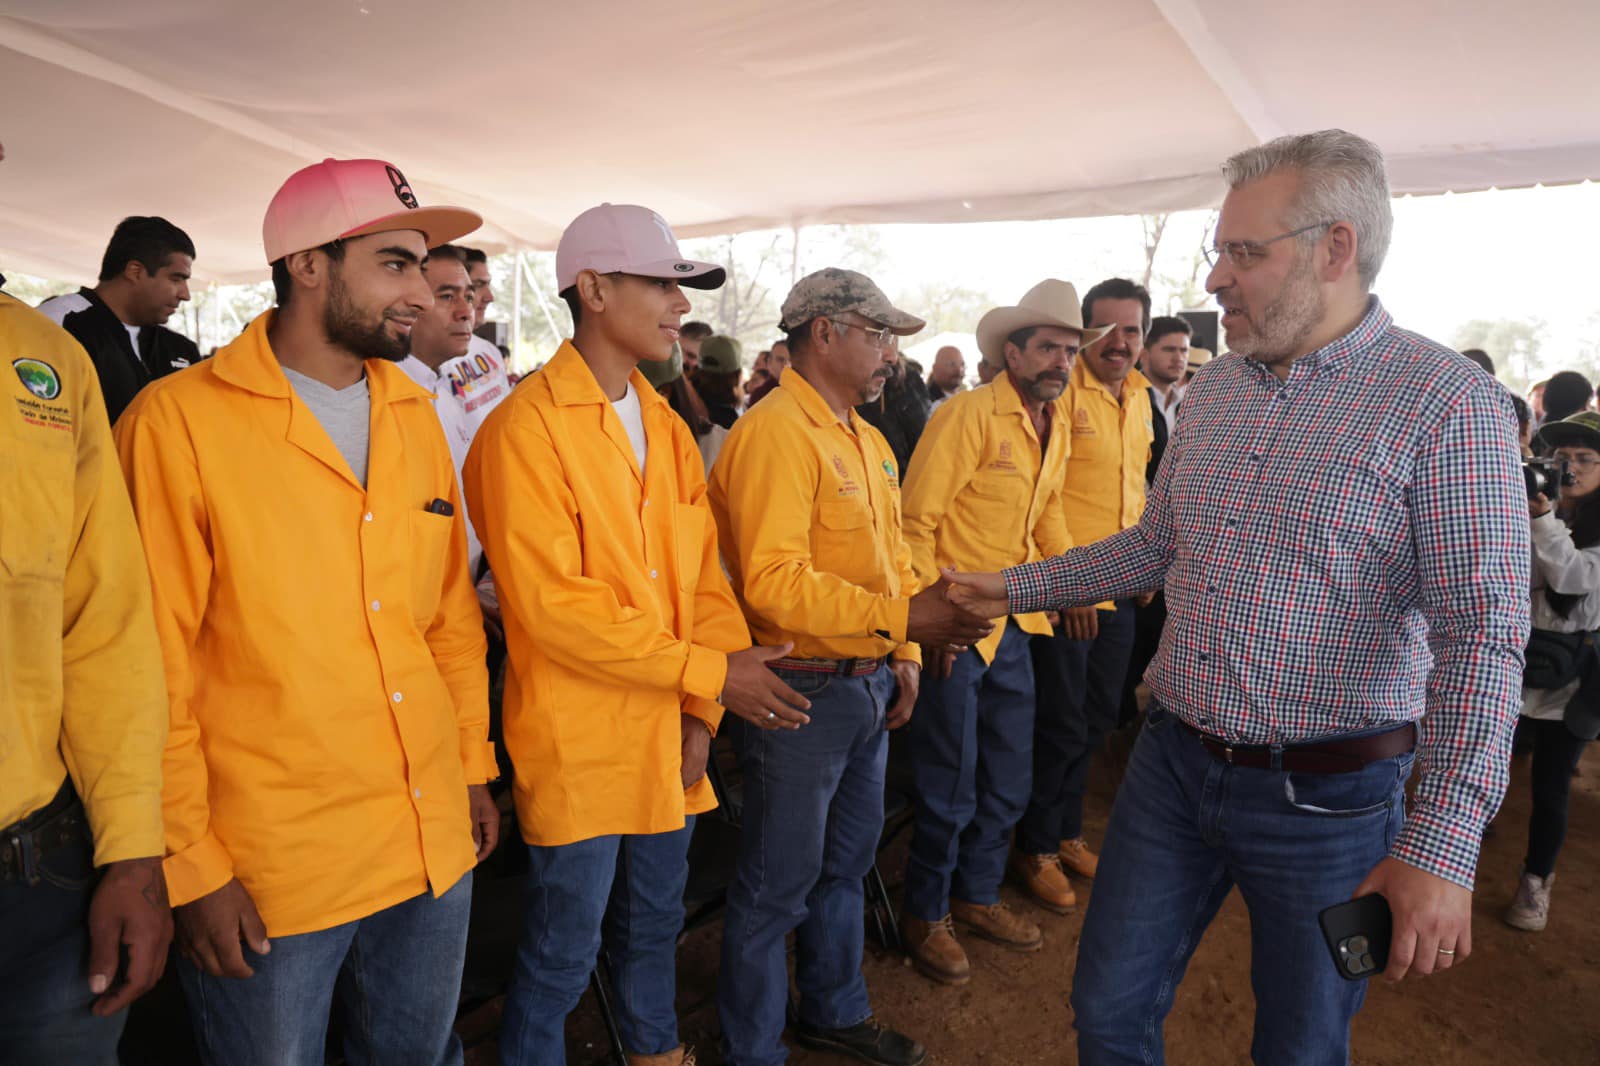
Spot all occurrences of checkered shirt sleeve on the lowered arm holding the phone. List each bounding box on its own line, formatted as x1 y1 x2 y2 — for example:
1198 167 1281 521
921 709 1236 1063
1392 381 1531 888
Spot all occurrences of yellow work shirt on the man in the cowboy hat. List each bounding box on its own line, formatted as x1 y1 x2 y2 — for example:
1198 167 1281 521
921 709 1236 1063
904 371 1072 663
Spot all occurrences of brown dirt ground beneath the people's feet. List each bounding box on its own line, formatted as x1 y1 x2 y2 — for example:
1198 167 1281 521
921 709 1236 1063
461 736 1600 1066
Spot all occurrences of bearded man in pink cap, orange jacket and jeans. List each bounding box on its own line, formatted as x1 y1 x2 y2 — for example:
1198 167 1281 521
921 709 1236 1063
117 160 499 1066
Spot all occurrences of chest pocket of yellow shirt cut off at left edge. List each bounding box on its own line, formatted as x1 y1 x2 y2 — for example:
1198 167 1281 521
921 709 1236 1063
0 427 72 581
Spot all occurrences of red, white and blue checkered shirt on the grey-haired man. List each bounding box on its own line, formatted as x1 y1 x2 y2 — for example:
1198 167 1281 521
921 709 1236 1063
1005 298 1530 888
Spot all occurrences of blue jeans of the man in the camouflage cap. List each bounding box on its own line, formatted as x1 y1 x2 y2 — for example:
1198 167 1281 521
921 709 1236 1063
717 666 894 1066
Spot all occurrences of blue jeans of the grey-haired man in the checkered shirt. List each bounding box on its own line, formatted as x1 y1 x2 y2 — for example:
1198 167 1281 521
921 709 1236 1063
1072 703 1411 1066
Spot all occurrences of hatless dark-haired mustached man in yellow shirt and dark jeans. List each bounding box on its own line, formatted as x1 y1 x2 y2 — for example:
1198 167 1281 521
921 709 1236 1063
1011 277 1155 914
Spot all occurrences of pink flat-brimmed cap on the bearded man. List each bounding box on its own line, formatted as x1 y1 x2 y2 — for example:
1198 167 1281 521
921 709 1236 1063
261 158 483 262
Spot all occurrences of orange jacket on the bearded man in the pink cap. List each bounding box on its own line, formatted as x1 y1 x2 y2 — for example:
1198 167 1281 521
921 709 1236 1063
115 312 494 936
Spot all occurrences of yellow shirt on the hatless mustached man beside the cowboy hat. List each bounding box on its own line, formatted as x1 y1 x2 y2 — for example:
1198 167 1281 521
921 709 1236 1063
1061 359 1155 544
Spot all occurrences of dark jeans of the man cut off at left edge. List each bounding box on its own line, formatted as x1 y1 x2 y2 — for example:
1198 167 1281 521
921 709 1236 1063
0 784 128 1066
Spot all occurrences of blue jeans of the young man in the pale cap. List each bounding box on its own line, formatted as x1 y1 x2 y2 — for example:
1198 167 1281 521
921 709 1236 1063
499 818 694 1066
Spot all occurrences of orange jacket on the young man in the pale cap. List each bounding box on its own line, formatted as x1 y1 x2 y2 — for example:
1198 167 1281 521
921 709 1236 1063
462 341 750 847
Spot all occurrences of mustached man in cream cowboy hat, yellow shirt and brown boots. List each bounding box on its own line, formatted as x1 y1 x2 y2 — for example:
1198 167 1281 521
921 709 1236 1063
901 279 1107 984
